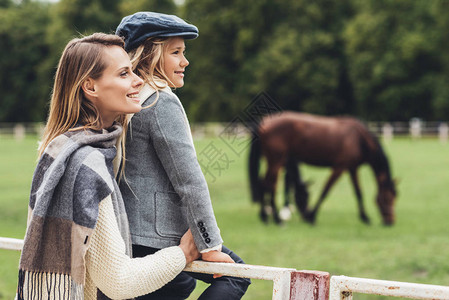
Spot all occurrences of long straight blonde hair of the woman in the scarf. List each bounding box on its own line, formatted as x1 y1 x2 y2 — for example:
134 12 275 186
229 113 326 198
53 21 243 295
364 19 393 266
38 33 127 157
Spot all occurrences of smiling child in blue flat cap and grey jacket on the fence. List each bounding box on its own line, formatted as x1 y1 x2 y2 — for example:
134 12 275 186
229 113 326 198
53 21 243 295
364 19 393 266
116 12 250 299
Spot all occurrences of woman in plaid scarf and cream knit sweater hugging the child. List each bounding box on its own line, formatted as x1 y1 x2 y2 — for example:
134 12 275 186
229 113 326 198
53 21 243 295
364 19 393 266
17 33 199 299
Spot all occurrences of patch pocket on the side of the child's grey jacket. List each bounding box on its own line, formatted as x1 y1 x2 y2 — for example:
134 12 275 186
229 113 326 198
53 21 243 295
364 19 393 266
154 192 189 238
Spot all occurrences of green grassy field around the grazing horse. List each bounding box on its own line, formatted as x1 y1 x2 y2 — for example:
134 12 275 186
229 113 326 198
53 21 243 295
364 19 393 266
0 137 449 299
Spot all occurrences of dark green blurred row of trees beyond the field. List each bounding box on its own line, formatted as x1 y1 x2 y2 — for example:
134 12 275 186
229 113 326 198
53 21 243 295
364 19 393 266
0 0 449 122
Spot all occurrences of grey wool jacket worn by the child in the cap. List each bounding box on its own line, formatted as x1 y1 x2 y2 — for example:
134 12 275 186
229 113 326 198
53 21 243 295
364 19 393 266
120 85 223 251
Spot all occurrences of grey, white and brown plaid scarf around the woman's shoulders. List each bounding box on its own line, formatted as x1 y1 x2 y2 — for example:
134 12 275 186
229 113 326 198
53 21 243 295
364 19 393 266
17 124 131 300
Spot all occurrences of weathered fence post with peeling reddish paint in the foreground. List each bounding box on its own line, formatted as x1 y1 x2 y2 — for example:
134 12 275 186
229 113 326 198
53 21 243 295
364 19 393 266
290 270 330 300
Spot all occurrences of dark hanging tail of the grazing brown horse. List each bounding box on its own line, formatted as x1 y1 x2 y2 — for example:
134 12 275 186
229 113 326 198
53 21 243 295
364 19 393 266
248 128 262 202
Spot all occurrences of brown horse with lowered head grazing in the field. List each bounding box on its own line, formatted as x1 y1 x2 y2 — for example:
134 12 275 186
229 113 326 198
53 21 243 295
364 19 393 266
249 112 396 225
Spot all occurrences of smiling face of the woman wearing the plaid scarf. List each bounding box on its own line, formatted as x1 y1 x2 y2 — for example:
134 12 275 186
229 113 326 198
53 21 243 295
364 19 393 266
83 46 143 128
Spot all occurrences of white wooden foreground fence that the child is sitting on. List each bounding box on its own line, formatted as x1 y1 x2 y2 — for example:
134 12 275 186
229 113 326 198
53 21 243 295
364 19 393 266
0 237 449 300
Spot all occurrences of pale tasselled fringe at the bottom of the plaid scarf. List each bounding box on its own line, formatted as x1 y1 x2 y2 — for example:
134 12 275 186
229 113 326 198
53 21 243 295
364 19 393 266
17 270 84 300
